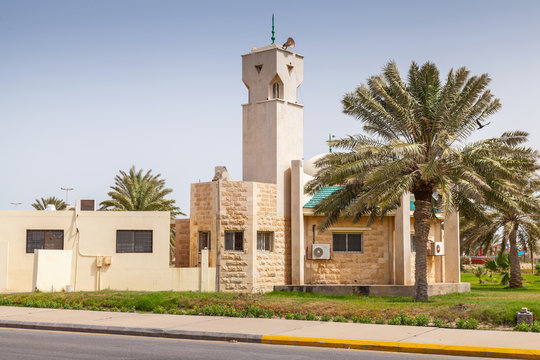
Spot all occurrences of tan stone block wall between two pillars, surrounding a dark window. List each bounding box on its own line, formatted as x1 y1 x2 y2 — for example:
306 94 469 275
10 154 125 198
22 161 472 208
304 216 394 284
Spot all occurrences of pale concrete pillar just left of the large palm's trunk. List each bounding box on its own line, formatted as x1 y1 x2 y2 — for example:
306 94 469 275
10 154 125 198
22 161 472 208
394 193 414 285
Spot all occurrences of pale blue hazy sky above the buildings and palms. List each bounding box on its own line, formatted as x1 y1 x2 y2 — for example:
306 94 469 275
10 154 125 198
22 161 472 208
0 0 540 212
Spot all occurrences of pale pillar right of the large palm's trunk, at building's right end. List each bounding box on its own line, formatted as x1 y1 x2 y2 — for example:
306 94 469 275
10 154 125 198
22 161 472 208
444 211 460 283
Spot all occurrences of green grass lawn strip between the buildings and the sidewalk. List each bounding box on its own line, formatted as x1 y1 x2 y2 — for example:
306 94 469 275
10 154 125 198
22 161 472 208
0 273 540 327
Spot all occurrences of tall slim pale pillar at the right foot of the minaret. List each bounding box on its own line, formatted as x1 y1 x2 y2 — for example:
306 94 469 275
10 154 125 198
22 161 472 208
291 160 305 285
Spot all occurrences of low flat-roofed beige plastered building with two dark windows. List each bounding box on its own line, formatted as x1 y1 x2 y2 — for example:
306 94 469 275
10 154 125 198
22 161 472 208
0 207 215 292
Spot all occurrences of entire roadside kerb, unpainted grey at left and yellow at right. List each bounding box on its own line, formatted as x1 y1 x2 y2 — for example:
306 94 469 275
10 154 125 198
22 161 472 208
0 320 540 360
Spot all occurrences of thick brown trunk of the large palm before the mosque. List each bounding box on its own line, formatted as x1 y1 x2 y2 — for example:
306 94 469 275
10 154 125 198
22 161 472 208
414 191 432 301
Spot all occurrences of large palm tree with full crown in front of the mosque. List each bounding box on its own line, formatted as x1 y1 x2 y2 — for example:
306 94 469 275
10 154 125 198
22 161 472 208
308 62 501 301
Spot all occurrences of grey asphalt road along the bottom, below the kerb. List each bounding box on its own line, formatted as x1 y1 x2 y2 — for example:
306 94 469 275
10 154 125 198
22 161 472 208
0 328 486 360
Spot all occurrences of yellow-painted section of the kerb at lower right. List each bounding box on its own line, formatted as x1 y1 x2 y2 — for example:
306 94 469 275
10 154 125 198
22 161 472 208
262 335 540 360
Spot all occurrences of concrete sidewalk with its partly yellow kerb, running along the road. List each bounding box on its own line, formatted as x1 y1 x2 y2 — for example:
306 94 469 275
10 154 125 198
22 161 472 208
0 306 540 359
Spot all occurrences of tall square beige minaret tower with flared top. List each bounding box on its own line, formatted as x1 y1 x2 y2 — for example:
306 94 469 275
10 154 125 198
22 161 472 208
242 41 304 217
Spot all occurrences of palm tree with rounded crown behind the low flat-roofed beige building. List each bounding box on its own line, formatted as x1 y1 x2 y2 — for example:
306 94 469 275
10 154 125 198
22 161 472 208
100 166 185 259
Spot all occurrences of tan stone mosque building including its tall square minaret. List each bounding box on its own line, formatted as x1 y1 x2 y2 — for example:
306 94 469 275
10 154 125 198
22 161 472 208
176 44 468 295
